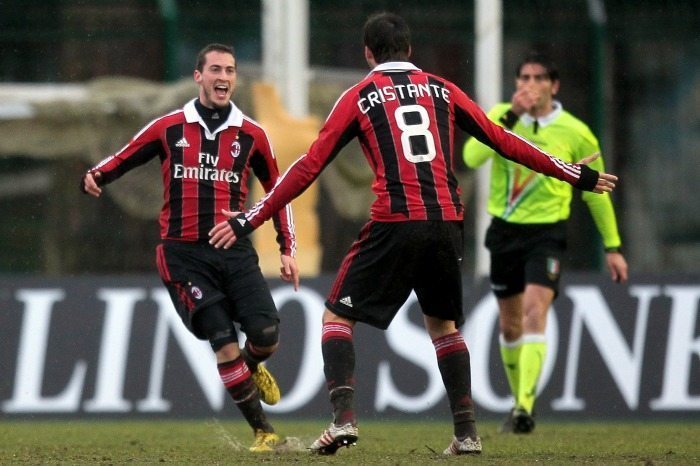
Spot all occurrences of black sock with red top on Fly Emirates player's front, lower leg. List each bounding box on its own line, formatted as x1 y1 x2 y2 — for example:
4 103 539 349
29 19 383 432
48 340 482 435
217 357 275 432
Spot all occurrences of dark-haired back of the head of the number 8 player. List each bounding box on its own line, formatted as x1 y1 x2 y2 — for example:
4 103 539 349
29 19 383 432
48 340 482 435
364 12 411 63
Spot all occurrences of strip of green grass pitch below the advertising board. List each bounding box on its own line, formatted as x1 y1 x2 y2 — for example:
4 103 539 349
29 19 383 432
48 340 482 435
0 419 700 465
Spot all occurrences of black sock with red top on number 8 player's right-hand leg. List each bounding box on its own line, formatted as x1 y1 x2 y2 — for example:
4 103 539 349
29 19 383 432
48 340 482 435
433 332 476 440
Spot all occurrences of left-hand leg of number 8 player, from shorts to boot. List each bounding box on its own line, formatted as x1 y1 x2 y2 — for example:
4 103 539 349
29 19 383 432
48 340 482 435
310 221 411 454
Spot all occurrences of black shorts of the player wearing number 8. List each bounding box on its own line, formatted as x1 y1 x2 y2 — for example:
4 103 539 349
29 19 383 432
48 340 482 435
326 221 464 329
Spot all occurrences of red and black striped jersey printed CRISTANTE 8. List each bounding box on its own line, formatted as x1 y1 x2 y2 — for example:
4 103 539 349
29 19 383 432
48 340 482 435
246 62 598 227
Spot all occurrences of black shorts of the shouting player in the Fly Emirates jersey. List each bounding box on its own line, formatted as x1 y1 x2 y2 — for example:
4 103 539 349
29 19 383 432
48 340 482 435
156 238 279 340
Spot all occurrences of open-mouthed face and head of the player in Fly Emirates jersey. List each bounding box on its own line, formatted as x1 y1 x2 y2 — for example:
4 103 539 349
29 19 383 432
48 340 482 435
194 50 236 108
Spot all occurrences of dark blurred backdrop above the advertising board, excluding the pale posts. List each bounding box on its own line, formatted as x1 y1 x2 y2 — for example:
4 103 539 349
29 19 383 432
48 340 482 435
0 0 700 275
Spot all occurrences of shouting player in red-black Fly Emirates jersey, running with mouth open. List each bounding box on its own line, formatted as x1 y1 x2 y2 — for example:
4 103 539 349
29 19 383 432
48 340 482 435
81 44 299 452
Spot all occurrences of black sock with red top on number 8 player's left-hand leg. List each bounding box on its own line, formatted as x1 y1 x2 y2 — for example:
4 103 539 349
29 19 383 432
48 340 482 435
321 322 356 425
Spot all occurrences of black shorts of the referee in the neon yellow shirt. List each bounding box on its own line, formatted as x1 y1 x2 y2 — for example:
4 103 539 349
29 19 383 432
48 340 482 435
485 217 566 298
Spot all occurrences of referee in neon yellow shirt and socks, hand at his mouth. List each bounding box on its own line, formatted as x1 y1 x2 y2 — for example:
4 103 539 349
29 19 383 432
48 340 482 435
463 53 627 434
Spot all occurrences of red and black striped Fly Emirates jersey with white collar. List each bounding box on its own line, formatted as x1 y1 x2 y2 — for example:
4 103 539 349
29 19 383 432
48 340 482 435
91 99 296 255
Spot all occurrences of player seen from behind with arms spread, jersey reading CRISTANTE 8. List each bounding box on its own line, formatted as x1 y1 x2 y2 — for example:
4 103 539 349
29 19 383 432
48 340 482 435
210 13 616 455
